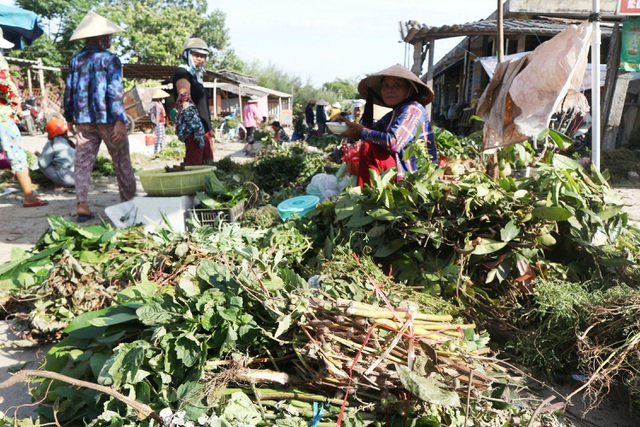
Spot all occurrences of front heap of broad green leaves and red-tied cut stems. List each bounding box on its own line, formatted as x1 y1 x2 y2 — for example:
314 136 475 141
0 220 560 426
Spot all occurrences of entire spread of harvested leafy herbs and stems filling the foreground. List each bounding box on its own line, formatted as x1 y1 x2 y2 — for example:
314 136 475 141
0 135 640 427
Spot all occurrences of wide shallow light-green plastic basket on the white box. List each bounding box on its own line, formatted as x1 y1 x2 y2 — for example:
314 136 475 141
137 166 215 197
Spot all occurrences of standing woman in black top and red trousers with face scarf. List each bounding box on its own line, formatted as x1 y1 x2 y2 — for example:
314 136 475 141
173 38 213 166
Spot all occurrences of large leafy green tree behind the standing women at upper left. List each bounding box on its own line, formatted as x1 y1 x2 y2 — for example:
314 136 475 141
12 0 243 70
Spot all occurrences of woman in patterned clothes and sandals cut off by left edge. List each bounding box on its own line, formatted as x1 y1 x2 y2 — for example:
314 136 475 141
0 28 49 208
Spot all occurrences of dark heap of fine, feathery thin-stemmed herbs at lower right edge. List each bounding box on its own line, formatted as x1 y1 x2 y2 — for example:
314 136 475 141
510 279 640 417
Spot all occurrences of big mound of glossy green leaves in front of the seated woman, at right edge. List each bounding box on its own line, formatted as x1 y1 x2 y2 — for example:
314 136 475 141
316 155 640 297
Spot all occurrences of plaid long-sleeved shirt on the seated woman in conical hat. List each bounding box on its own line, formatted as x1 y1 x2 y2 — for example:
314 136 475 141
360 101 438 176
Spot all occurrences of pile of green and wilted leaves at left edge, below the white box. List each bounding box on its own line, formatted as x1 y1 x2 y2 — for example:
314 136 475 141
0 216 156 343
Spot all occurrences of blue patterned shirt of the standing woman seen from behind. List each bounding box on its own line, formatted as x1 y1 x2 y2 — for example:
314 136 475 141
64 45 126 123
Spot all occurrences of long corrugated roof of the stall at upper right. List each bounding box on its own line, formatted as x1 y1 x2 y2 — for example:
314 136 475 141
400 19 611 44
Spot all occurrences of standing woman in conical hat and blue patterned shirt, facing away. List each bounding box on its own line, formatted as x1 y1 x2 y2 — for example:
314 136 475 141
64 11 136 222
